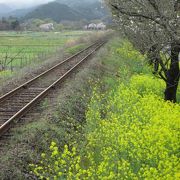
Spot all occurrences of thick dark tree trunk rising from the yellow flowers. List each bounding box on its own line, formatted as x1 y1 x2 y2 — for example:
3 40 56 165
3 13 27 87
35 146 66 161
164 43 180 103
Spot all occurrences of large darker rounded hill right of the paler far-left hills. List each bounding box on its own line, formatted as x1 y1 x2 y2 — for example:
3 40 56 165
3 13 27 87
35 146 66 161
23 0 109 22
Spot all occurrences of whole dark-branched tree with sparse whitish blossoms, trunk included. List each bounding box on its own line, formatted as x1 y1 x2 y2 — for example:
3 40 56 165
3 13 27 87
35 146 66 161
105 0 180 102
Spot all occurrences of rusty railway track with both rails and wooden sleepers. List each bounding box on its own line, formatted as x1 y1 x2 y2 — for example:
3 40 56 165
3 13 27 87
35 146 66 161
0 41 105 137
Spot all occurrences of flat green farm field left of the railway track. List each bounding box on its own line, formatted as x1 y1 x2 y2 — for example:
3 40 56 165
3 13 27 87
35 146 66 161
0 31 88 79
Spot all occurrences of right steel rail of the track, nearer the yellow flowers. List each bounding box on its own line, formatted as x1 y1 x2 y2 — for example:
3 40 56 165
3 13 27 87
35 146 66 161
0 42 105 137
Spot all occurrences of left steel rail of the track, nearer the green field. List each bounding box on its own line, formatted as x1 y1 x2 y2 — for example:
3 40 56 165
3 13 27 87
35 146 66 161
0 42 97 104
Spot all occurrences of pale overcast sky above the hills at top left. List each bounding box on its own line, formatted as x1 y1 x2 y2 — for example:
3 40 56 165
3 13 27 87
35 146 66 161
0 0 54 8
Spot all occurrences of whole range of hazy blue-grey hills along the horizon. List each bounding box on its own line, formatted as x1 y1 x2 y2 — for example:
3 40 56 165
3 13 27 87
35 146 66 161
0 0 110 23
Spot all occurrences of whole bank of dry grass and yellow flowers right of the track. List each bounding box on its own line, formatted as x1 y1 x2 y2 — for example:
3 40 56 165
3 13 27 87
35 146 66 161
0 34 180 179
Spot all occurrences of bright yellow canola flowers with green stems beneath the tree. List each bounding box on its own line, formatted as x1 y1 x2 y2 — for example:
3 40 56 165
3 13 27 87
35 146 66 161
30 40 180 180
